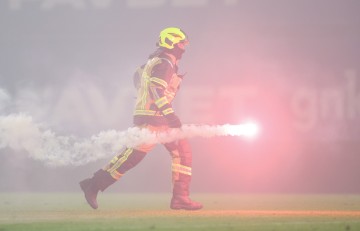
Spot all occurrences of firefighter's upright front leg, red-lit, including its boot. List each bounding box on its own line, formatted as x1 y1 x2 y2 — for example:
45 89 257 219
165 139 203 210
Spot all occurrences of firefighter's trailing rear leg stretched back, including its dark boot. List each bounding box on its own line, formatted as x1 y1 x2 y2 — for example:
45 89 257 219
80 145 152 209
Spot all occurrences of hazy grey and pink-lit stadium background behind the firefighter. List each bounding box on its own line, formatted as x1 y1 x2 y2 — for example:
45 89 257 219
0 0 360 193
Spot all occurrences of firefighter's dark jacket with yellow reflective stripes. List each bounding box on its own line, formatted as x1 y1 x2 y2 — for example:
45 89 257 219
134 53 182 126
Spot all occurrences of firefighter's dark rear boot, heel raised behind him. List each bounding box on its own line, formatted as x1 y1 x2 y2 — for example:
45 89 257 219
79 169 116 209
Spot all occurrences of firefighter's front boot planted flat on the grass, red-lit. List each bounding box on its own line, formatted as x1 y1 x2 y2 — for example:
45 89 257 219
170 181 203 210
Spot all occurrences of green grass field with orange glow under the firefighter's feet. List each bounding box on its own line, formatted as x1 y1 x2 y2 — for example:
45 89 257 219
0 193 360 231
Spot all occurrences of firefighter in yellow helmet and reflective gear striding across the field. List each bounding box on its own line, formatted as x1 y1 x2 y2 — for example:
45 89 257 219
79 27 202 210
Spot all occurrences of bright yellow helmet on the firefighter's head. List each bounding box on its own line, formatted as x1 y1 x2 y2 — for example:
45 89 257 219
158 27 189 49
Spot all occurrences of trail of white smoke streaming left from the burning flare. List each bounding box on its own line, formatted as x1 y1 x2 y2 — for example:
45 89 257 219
0 114 253 166
